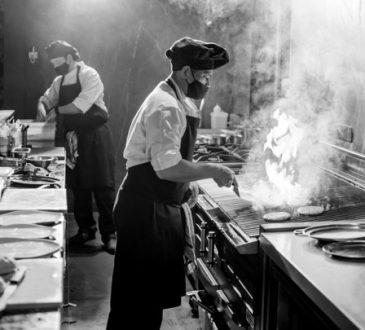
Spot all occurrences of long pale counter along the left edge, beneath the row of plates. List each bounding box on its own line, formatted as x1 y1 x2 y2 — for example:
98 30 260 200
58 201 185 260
0 143 67 330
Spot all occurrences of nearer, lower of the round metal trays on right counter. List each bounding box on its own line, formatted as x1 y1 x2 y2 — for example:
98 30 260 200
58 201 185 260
322 240 365 259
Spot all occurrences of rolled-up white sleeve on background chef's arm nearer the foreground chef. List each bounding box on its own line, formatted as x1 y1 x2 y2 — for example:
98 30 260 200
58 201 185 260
72 69 104 113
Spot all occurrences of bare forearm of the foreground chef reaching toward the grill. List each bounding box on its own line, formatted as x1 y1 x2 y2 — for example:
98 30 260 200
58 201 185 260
156 159 217 182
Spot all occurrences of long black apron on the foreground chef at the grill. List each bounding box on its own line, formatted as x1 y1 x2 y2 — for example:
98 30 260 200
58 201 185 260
110 80 200 312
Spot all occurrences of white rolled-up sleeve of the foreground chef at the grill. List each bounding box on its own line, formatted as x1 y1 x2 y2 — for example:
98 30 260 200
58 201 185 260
145 107 186 171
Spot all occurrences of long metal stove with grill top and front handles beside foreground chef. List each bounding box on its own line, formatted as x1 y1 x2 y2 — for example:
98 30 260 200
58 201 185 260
189 151 365 330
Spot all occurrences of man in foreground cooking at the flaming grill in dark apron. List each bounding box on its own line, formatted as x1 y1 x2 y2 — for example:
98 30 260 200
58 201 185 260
107 37 235 330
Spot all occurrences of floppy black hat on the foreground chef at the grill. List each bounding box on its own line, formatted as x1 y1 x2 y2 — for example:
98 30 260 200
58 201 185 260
166 37 229 71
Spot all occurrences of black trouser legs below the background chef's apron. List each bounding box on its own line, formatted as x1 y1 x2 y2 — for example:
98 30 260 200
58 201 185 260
72 188 116 243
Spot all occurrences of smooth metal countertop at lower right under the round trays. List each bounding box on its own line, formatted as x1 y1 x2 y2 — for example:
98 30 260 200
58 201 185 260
260 232 365 330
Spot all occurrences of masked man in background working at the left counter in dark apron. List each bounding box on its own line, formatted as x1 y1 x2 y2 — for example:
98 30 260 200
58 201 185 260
37 40 116 254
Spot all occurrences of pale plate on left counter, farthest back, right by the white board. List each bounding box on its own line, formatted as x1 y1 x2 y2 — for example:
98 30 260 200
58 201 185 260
0 210 62 226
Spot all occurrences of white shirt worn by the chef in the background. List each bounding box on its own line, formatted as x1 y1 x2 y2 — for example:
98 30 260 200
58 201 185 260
40 61 108 113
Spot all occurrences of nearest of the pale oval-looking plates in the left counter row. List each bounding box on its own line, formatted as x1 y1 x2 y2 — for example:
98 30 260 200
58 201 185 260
0 238 61 259
